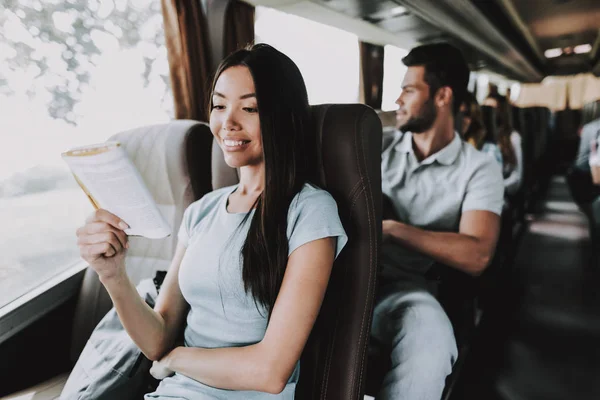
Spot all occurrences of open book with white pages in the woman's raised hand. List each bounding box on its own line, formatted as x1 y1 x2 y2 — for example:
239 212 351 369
62 142 171 239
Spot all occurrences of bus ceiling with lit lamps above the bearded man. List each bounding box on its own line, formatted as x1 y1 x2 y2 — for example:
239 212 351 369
244 0 600 82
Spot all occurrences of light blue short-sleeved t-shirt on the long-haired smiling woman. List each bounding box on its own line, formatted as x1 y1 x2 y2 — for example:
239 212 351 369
145 184 348 400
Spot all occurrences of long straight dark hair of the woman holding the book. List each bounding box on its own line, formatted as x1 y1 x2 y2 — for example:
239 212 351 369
209 44 309 315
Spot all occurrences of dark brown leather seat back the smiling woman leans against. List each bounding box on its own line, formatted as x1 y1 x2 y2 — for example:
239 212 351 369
212 104 382 400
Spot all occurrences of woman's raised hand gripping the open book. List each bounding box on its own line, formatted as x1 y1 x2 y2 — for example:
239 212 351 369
77 209 129 281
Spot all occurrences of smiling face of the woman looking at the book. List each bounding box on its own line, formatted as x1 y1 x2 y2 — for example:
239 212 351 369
210 66 263 168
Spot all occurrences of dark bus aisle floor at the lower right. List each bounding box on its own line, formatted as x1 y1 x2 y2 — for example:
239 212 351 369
450 176 600 400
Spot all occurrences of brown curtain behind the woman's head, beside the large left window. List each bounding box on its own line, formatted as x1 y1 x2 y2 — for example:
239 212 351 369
161 0 254 199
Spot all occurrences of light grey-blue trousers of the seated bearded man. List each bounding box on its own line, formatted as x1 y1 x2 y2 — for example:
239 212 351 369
371 281 458 400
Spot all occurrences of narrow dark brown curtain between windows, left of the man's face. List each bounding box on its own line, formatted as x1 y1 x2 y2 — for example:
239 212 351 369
360 42 384 110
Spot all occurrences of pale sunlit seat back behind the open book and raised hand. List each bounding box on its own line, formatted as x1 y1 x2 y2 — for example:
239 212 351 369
71 120 210 361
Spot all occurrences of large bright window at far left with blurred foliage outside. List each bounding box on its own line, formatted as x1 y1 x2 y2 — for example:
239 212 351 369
0 0 173 308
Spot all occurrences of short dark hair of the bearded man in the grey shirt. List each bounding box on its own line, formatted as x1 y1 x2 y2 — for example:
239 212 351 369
402 43 470 115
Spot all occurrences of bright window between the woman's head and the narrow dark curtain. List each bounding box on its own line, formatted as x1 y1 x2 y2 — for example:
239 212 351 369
255 7 360 104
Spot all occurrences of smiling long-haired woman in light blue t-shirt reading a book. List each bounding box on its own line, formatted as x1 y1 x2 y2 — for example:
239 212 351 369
67 44 348 400
